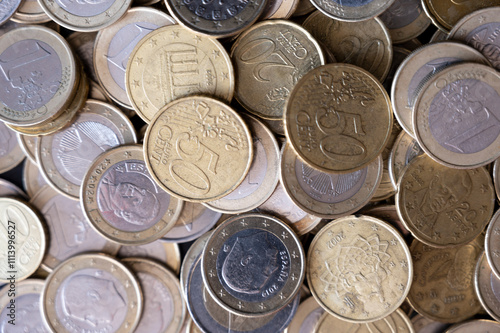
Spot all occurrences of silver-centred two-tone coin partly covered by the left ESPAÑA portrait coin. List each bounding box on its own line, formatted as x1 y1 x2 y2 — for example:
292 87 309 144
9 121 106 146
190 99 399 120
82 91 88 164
37 100 136 200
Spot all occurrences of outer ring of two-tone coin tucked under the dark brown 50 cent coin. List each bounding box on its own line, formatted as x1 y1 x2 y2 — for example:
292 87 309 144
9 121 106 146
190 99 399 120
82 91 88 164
280 144 383 219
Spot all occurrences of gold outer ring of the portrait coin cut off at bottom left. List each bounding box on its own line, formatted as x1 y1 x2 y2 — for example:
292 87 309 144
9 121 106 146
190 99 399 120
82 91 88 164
40 253 144 333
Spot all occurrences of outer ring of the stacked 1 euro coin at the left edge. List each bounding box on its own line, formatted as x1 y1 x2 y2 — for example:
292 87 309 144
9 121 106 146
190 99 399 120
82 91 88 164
0 26 80 126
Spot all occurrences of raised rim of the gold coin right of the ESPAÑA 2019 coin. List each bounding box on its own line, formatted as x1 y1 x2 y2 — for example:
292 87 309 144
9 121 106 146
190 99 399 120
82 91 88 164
306 215 413 324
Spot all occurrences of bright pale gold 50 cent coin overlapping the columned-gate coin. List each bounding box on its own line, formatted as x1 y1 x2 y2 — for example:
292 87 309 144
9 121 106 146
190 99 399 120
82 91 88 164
144 94 253 202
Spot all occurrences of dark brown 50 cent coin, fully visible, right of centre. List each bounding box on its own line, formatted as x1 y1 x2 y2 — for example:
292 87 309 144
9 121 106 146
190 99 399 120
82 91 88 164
284 64 393 173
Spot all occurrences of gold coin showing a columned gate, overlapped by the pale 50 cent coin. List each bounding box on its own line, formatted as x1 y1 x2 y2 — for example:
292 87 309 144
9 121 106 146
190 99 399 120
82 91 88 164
125 25 234 123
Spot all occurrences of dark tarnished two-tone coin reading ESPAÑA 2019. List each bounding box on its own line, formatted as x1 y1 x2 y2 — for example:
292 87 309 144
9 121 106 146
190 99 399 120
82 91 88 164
202 213 305 317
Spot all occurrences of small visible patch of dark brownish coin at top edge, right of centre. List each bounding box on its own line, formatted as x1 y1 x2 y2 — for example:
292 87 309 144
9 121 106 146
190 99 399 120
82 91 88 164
379 0 431 44
